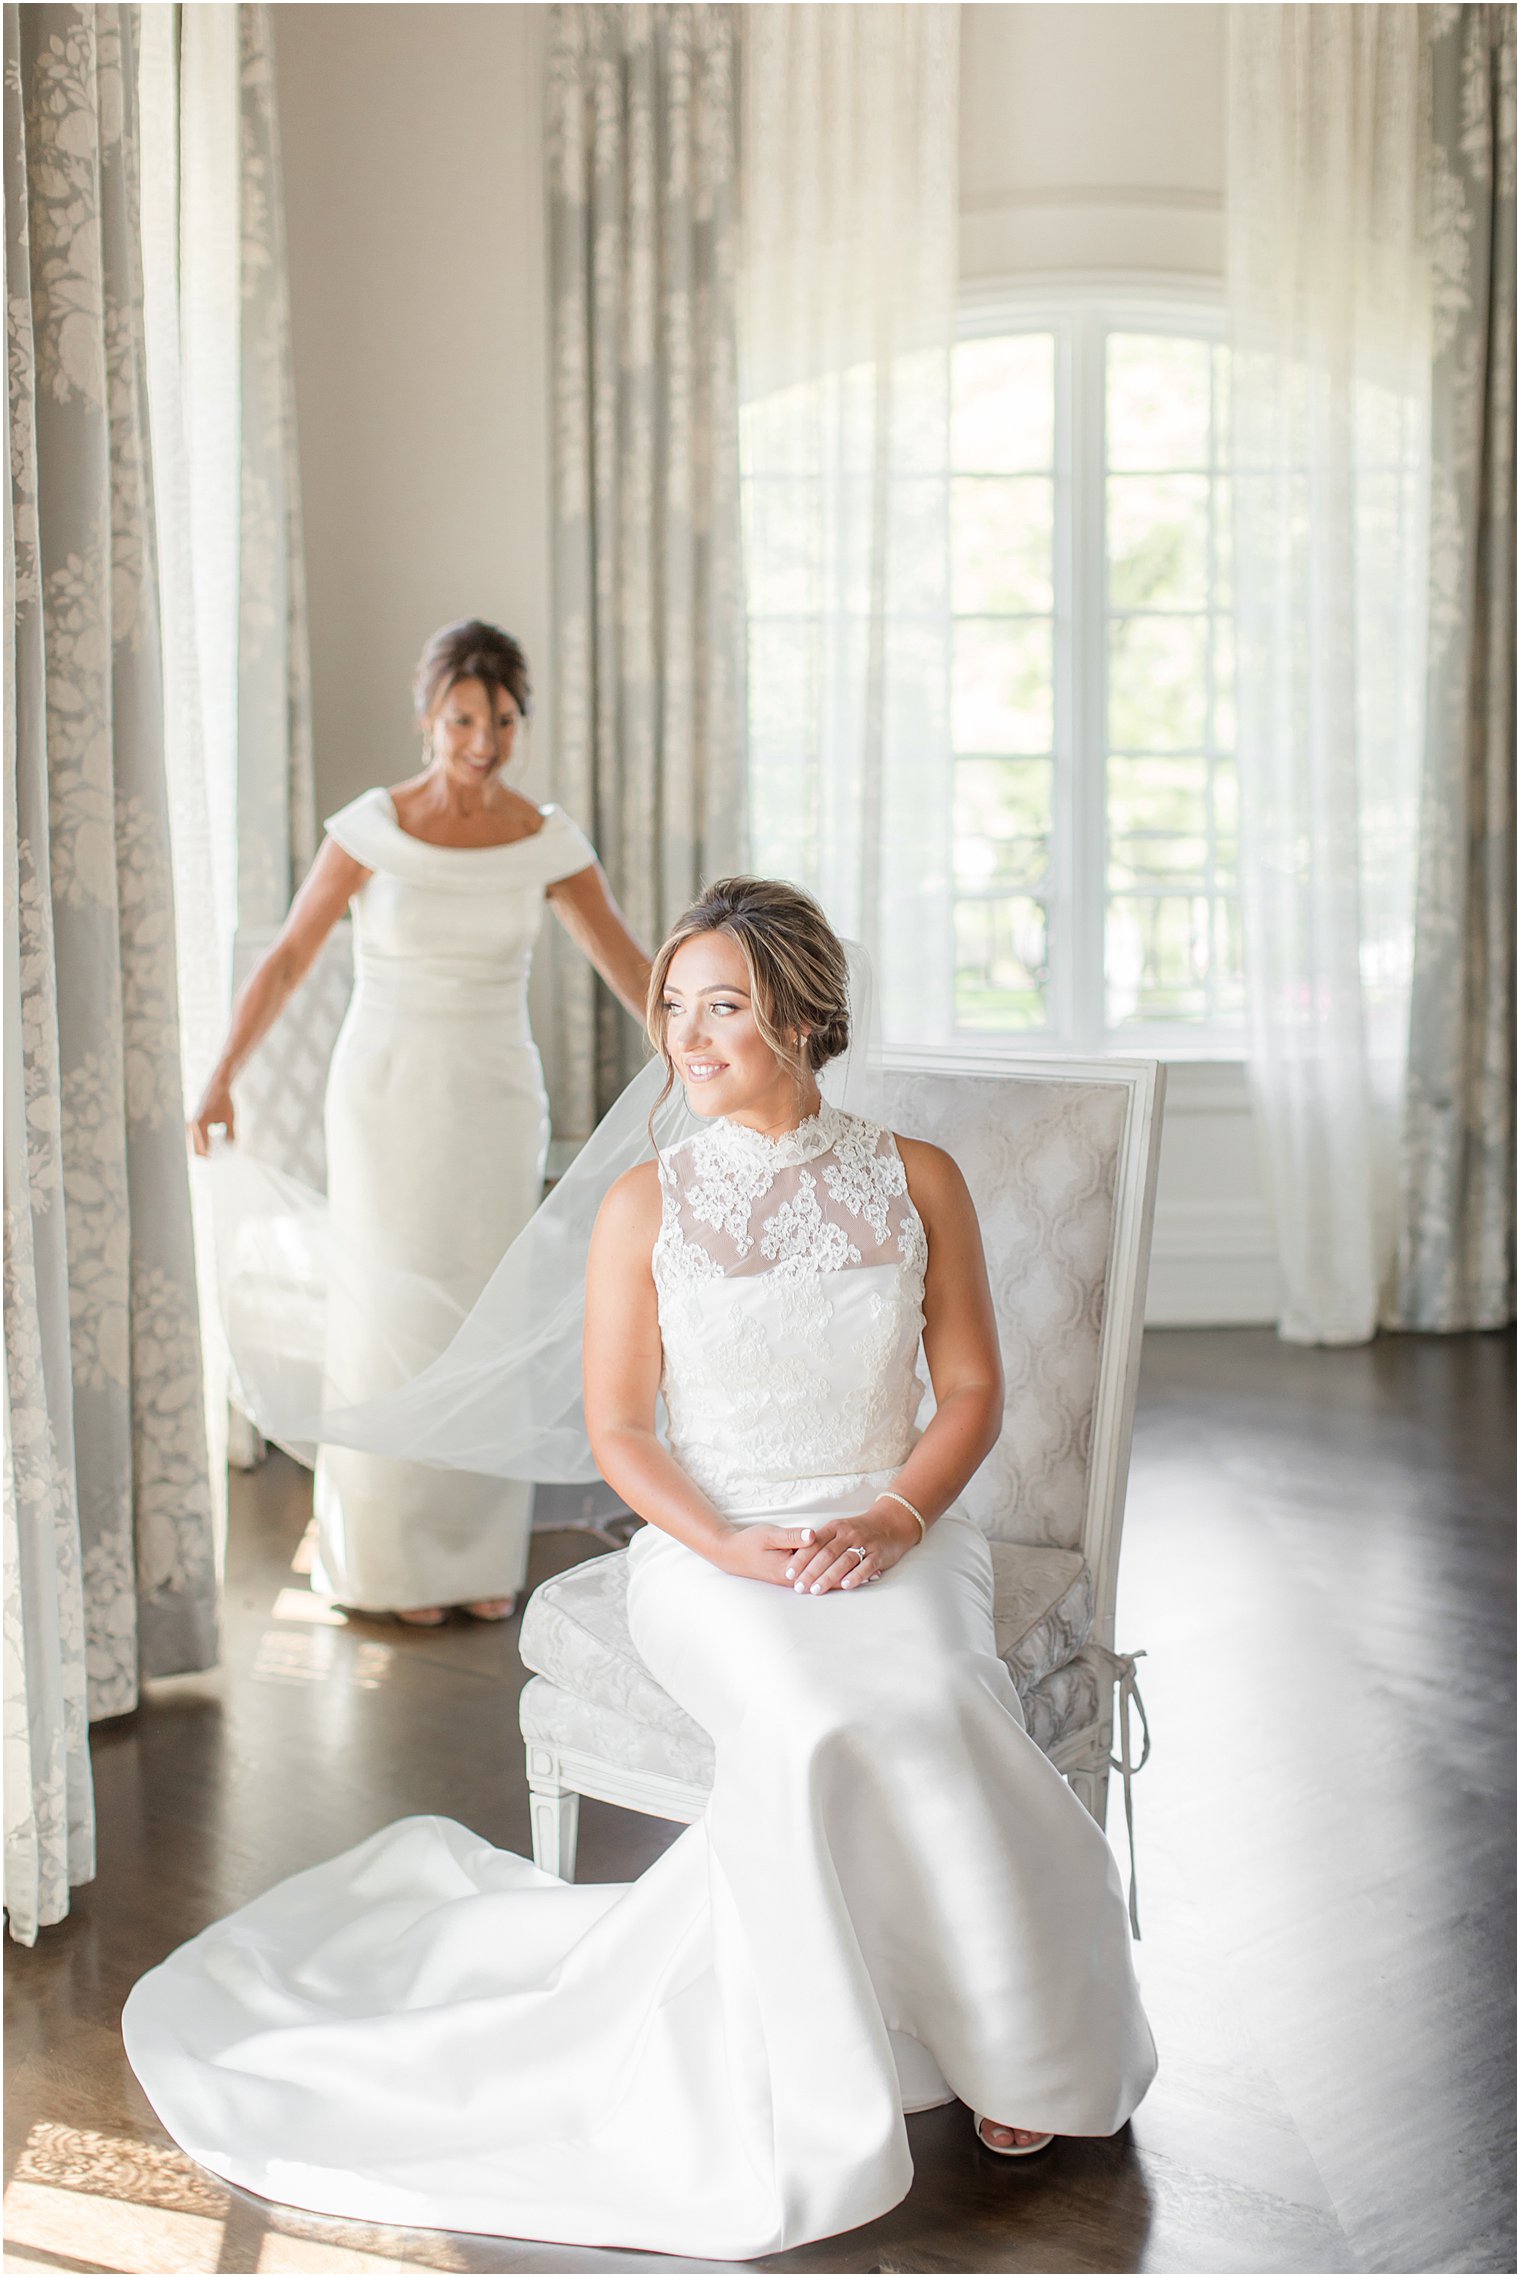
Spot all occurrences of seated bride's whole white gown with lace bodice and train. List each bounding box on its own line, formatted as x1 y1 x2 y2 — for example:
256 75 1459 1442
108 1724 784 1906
125 1107 1154 2259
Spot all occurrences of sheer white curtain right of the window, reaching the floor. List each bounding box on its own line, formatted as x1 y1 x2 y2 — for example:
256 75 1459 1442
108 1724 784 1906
1229 5 1431 1343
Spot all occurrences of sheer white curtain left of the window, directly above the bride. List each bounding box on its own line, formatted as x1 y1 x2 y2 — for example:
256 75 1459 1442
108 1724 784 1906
740 5 958 1041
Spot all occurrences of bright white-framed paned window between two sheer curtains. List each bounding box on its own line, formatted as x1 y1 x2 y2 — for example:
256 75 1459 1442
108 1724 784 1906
951 301 1242 1050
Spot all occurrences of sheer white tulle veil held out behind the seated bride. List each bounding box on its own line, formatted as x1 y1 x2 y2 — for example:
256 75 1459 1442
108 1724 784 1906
205 943 881 1482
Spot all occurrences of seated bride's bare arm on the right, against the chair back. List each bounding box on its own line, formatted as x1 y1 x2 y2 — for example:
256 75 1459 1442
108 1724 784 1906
799 1139 1003 1589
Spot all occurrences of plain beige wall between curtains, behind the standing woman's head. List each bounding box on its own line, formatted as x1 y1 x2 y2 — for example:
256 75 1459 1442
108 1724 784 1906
271 5 553 813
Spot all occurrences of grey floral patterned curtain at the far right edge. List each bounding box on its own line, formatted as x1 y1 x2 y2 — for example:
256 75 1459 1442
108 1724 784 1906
1395 7 1515 1330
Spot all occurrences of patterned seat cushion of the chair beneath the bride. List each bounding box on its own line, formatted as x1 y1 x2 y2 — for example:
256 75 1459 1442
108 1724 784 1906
519 1542 1092 1748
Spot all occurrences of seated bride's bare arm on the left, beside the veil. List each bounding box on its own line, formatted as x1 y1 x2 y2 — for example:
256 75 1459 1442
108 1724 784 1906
583 1161 801 1587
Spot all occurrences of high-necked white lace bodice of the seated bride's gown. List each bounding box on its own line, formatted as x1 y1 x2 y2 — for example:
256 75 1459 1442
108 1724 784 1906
653 1104 928 1516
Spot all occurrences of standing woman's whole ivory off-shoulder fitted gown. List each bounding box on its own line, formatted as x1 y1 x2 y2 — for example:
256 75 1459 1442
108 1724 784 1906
314 790 596 1610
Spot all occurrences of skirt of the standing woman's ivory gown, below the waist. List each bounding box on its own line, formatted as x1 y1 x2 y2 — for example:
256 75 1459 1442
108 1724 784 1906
314 981 548 1612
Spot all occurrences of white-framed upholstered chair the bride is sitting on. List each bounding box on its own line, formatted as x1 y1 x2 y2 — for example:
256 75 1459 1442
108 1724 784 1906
519 1054 1163 1913
